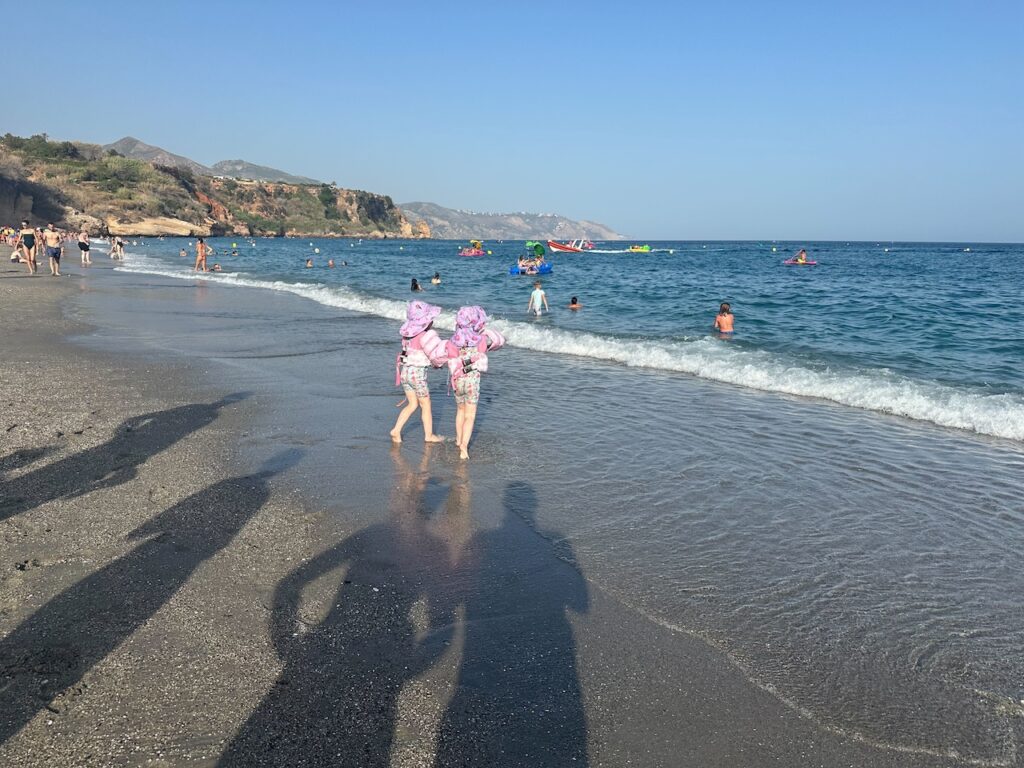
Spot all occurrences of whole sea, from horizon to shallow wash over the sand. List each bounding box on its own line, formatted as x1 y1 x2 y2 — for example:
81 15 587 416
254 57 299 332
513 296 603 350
84 237 1024 766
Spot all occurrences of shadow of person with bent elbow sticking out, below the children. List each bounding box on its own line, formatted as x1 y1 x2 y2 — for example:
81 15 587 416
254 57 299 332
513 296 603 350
219 445 453 768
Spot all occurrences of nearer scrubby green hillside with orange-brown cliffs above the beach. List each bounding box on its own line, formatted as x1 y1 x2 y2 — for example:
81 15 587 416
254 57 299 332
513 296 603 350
0 134 430 238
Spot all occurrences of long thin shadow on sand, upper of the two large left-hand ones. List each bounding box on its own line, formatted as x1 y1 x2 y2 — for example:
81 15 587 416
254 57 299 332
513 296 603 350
0 394 246 520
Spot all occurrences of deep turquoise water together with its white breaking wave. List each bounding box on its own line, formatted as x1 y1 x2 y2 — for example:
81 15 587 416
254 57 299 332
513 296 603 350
119 238 1024 440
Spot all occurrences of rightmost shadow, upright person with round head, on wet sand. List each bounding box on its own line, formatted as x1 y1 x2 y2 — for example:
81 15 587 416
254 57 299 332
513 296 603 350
436 482 589 768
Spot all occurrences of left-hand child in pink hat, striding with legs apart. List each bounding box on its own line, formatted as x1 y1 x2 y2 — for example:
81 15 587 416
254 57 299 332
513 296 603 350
391 301 447 442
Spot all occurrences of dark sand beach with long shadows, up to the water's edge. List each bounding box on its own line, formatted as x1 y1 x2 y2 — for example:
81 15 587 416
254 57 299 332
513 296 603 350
0 264 999 768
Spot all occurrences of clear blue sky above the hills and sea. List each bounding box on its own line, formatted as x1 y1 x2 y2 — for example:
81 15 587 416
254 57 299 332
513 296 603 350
8 0 1024 242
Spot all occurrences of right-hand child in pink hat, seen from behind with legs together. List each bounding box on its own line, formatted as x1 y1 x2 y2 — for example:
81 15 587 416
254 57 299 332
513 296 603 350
445 306 505 459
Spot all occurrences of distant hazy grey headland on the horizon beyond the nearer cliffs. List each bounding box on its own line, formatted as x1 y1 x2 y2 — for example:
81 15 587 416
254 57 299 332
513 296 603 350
398 203 625 240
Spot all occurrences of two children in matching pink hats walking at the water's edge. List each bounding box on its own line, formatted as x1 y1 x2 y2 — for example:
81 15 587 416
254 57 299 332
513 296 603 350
391 300 505 459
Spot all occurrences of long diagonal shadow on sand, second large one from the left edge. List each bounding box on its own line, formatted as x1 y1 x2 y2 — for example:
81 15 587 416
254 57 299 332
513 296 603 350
0 450 300 742
